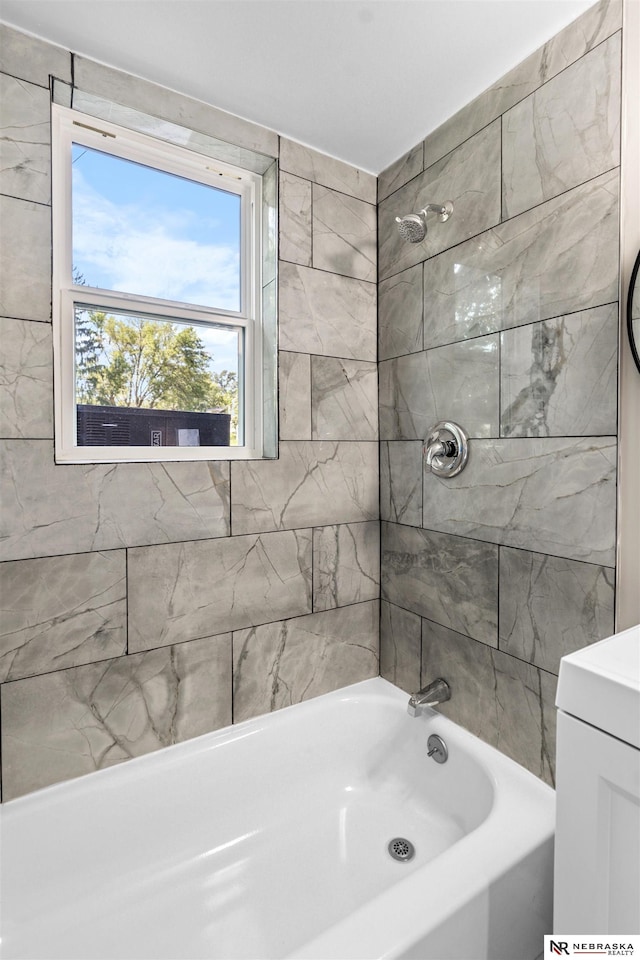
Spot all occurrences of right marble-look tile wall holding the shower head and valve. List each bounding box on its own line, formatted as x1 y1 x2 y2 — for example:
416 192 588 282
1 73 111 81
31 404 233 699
378 0 621 783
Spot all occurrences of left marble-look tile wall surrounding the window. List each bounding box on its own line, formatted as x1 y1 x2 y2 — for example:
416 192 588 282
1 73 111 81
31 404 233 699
0 26 380 800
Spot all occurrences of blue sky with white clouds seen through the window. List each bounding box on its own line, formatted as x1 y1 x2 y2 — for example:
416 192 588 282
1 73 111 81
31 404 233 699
73 144 240 370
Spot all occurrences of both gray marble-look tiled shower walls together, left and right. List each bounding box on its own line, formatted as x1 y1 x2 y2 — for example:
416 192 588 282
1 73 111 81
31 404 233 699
0 0 620 799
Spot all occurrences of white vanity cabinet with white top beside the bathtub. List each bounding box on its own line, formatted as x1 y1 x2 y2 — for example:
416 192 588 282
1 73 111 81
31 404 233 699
553 627 640 934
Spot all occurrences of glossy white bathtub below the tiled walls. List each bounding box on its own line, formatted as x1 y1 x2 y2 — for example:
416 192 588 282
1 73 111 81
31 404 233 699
0 679 555 960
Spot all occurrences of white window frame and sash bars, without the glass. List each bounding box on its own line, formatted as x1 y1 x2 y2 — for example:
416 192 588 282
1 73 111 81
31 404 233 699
52 103 264 463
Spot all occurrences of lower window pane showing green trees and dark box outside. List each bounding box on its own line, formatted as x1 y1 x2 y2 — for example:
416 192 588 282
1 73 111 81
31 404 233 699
74 303 243 446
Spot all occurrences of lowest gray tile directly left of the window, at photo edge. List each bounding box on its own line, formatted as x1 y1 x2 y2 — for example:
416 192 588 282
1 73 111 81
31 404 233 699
0 317 53 438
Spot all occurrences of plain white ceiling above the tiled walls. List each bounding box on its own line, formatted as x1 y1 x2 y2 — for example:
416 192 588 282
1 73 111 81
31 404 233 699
0 0 593 174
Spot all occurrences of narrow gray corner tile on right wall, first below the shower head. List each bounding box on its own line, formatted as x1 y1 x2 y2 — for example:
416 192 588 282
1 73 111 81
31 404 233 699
378 264 422 360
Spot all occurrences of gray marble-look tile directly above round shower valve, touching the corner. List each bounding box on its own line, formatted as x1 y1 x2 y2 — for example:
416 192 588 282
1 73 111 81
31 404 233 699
380 334 499 440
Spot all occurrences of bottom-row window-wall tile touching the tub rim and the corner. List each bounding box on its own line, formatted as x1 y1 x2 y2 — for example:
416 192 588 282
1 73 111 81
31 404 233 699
233 600 379 723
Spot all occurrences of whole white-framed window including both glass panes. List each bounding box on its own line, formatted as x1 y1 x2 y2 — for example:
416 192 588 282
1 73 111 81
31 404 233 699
53 104 272 463
